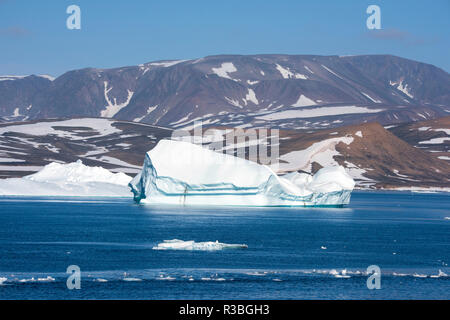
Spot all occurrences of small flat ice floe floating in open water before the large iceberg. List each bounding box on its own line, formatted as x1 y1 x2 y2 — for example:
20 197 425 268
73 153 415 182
152 239 248 251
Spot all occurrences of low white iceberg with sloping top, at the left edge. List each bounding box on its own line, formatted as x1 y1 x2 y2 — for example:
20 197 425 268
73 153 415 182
0 160 132 197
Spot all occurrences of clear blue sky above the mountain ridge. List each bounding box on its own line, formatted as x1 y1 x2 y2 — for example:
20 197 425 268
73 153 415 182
0 0 450 76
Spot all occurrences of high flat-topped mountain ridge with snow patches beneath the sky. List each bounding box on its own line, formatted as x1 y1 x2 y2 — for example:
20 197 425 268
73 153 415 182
0 54 450 129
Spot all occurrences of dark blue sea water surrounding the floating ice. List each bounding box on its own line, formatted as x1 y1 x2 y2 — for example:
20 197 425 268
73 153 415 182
0 192 450 299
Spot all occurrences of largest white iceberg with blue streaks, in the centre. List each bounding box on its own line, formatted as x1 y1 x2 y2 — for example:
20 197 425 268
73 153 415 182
129 139 355 207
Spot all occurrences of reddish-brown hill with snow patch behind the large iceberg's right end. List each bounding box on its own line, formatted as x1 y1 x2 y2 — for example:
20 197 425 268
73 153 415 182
280 123 450 188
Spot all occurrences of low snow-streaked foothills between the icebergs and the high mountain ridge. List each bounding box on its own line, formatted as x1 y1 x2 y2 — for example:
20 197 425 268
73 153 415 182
0 118 450 188
